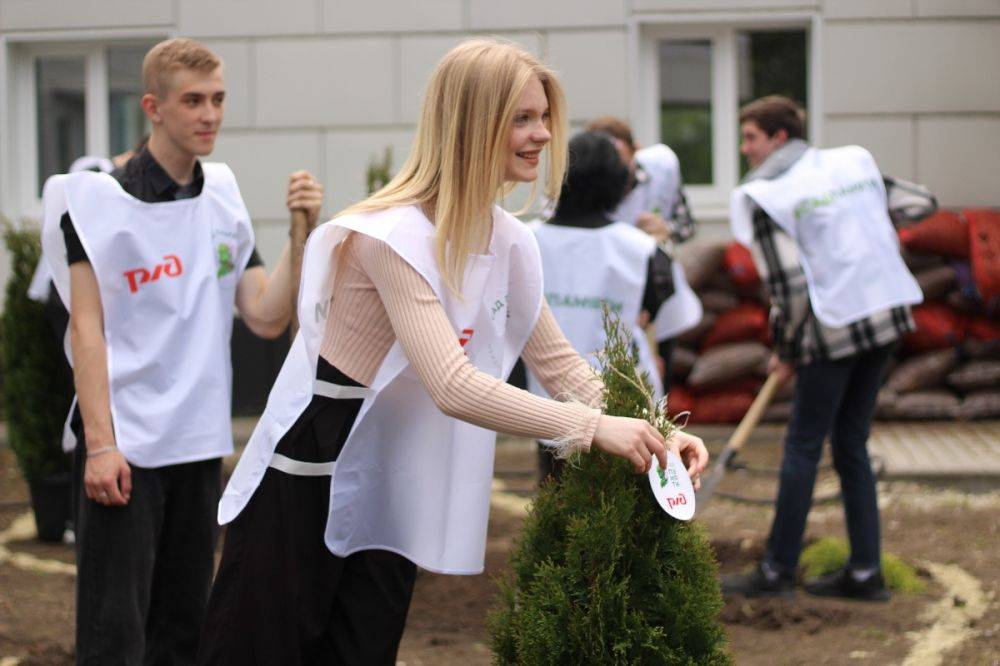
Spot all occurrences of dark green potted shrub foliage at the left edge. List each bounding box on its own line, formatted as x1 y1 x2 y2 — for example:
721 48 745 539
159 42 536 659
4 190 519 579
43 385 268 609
0 224 73 481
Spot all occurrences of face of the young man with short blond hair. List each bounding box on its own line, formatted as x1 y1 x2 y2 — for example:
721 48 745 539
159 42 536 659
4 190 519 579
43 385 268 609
143 67 226 156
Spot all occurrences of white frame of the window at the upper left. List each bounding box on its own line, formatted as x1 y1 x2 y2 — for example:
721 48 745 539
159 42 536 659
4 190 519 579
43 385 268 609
0 30 170 220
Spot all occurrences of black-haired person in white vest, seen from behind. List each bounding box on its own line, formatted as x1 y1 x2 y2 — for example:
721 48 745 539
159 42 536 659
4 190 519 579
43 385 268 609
528 131 674 479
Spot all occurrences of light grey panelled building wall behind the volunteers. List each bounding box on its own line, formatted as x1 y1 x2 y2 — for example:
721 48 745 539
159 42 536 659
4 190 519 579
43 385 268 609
0 0 1000 265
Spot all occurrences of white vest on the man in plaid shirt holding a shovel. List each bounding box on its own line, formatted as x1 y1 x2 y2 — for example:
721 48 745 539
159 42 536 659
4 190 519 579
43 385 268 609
730 146 923 327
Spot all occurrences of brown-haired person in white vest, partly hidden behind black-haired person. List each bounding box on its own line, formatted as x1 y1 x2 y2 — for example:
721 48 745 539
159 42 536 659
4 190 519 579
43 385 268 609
587 116 702 393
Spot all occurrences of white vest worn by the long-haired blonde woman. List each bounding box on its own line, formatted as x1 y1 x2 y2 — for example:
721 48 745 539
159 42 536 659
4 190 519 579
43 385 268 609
219 206 542 574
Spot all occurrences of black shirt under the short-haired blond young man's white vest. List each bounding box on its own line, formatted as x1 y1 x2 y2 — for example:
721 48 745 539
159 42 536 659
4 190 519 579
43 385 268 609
59 148 264 268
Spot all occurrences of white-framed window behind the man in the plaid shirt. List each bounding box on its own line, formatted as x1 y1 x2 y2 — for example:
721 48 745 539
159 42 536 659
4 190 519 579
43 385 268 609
634 17 813 218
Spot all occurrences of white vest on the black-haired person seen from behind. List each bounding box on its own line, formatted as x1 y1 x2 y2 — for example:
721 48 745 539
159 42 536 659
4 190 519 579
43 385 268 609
528 222 663 399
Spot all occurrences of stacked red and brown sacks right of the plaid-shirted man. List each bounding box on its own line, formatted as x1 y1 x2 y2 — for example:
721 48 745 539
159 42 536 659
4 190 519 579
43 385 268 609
877 210 1000 420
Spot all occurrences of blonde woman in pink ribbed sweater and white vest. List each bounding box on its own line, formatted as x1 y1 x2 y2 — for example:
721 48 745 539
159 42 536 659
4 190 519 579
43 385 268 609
199 39 707 664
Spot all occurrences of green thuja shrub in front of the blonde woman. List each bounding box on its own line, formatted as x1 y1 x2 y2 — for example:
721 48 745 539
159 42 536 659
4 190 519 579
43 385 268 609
489 310 731 665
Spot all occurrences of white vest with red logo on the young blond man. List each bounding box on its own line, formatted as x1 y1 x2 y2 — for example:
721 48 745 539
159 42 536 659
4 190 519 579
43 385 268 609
42 164 254 467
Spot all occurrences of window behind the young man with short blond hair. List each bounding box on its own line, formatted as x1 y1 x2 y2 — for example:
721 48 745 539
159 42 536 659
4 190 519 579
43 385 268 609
3 38 156 210
